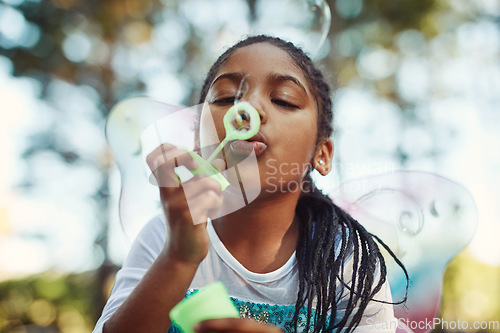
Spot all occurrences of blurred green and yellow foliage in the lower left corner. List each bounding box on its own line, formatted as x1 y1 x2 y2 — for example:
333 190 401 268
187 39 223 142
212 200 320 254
0 272 101 332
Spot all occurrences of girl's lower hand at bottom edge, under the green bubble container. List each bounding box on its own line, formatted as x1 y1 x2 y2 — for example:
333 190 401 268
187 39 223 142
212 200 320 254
194 318 283 333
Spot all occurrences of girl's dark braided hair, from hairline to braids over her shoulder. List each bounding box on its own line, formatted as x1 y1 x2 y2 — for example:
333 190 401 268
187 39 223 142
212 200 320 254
199 35 408 332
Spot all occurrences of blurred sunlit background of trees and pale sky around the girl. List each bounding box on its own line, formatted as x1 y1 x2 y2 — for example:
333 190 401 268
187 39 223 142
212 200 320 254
0 0 500 332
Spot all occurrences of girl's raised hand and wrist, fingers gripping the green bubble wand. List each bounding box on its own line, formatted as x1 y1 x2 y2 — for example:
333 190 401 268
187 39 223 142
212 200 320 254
146 144 222 264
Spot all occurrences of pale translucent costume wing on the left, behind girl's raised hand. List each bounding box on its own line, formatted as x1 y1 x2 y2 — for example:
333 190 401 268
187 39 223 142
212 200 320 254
106 97 192 240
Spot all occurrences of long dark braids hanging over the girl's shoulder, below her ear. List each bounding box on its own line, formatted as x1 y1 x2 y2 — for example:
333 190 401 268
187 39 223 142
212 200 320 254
294 180 408 332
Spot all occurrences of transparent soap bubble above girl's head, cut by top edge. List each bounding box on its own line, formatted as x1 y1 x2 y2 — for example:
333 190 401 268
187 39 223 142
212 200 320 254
252 0 331 58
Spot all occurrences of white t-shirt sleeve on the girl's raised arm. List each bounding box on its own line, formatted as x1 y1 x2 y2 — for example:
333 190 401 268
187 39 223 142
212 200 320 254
93 215 167 333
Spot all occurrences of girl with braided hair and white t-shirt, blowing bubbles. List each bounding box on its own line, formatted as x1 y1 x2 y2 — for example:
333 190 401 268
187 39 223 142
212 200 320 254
94 36 406 332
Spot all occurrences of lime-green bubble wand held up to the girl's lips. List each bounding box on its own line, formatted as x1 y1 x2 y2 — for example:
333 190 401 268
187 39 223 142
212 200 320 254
184 102 260 191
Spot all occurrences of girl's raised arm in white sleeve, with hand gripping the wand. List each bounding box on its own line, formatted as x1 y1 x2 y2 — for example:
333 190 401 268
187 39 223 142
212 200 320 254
95 144 222 333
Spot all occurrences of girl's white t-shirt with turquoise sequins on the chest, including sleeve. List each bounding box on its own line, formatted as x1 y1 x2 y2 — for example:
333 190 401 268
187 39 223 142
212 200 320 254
94 215 397 333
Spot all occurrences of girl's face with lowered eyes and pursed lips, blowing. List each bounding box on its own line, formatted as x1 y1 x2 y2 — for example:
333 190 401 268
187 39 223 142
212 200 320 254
200 43 328 193
